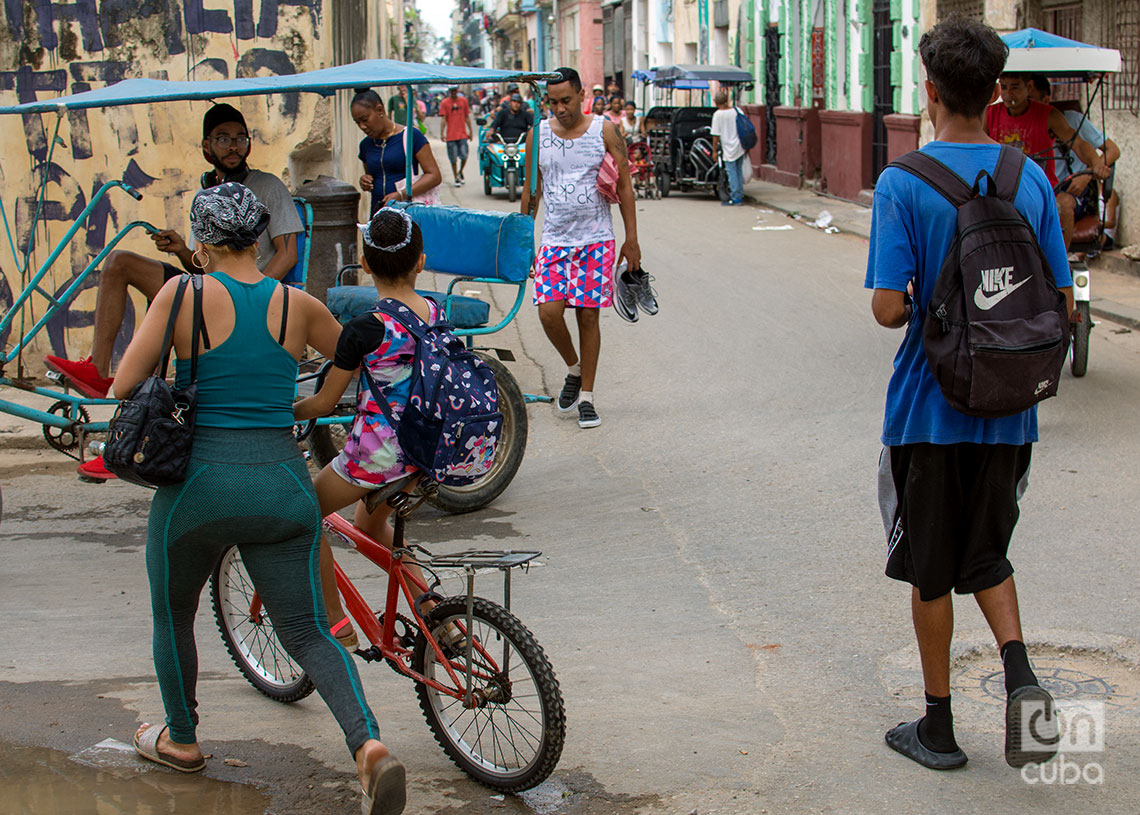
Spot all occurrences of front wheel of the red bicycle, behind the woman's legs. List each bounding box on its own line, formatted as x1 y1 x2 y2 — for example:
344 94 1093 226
210 546 314 702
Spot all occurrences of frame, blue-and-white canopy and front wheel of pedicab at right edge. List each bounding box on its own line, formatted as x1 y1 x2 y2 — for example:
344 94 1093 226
999 28 1122 377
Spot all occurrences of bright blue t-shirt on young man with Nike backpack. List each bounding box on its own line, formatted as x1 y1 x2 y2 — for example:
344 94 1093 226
864 141 1073 447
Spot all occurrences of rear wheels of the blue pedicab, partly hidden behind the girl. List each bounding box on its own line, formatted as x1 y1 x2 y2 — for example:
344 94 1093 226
307 351 528 514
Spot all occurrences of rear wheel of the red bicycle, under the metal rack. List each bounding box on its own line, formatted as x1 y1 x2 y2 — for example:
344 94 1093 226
412 597 565 792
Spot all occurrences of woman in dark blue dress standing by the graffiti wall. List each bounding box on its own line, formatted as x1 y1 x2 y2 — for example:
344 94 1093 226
350 88 443 214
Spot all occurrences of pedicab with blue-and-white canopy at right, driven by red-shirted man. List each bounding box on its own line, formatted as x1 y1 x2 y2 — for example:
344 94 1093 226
1002 28 1121 376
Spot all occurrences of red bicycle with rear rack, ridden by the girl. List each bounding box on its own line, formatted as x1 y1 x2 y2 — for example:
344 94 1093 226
211 476 565 792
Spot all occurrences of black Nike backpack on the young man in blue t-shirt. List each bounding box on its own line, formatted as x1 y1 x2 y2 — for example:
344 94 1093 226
889 147 1069 418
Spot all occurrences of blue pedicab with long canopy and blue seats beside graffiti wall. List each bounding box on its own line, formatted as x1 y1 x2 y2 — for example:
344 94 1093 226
0 59 549 512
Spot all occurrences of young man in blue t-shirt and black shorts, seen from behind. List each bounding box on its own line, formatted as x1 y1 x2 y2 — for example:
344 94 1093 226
865 17 1073 769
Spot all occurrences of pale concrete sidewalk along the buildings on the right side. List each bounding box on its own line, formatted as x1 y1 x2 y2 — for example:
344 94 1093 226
744 180 1140 331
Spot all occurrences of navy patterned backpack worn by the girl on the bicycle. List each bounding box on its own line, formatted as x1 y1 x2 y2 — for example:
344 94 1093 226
363 299 503 487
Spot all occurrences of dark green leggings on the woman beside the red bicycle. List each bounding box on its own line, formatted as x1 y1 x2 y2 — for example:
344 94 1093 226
146 426 380 755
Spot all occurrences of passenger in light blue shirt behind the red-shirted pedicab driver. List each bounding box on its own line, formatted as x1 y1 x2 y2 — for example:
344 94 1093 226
1029 74 1121 247
